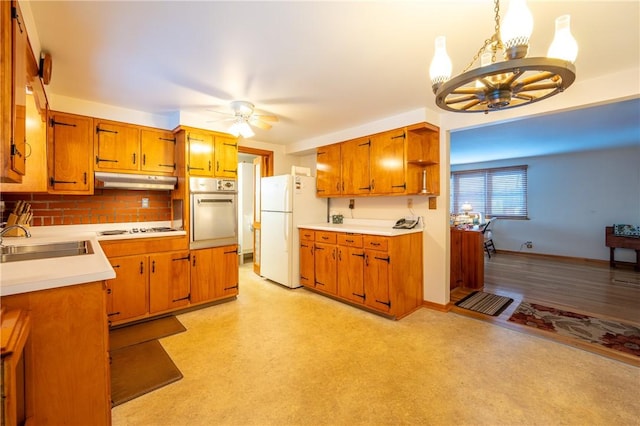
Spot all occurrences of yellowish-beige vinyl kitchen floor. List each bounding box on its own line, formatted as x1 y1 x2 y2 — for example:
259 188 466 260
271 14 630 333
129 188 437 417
112 264 640 426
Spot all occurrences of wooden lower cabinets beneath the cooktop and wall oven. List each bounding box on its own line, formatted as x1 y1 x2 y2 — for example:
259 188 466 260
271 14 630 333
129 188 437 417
100 238 239 326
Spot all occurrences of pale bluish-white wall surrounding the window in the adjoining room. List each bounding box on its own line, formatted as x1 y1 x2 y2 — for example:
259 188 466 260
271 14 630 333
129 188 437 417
451 145 640 261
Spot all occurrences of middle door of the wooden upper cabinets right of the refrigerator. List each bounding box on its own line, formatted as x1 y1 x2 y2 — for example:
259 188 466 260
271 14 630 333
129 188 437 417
342 137 371 195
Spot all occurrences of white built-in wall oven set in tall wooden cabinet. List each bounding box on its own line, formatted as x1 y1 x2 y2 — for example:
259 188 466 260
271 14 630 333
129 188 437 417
189 177 238 249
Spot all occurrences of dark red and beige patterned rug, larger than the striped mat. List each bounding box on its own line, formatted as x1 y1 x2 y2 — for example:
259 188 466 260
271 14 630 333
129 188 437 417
509 302 640 357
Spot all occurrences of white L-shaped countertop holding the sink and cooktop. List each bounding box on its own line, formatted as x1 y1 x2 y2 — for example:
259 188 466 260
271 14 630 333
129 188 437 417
0 222 186 296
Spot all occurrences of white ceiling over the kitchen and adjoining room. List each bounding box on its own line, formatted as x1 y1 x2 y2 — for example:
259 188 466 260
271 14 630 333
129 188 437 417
29 0 640 162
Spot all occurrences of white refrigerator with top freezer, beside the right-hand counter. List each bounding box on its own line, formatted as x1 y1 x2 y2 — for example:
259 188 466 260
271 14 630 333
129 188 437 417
260 175 328 288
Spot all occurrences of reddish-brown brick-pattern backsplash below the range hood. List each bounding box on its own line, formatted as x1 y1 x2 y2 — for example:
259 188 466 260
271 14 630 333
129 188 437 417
2 189 171 226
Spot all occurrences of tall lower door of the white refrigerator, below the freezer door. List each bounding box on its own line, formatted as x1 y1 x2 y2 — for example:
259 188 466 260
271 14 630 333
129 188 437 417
260 211 298 287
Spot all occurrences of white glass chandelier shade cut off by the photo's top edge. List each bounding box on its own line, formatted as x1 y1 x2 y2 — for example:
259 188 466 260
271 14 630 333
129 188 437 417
500 0 533 59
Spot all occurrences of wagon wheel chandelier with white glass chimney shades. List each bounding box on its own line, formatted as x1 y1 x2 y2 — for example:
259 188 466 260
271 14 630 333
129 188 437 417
429 0 578 114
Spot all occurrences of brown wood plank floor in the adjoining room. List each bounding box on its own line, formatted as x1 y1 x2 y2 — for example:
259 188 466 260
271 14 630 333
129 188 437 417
451 252 640 324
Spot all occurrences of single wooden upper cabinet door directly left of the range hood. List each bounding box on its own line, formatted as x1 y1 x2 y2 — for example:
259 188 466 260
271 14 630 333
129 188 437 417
47 111 93 194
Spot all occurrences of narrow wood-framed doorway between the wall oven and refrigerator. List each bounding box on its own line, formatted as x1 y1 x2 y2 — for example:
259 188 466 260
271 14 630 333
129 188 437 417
238 146 273 274
